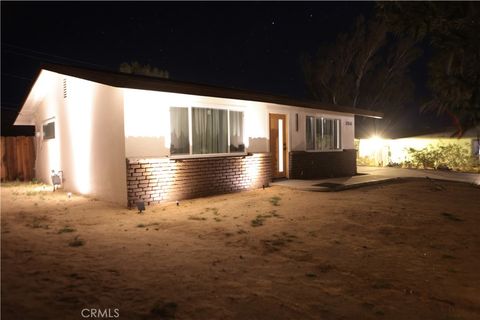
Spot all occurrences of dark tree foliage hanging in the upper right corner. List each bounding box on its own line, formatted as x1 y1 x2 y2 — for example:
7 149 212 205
377 2 480 137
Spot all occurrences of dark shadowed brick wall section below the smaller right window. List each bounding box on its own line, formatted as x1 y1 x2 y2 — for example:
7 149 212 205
289 150 357 179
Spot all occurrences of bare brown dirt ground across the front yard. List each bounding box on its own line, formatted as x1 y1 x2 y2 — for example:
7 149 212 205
1 179 480 320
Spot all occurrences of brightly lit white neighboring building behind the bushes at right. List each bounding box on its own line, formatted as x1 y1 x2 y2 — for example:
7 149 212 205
355 127 480 166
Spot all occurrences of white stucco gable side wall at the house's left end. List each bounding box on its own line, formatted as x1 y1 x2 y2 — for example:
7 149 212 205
32 71 127 205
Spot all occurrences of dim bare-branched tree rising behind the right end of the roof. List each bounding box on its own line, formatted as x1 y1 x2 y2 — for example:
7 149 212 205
302 16 421 136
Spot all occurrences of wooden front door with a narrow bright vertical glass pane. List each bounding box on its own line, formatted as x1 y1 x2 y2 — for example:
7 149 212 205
270 113 287 178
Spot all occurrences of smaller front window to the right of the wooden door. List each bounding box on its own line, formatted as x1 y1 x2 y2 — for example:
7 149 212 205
305 116 342 151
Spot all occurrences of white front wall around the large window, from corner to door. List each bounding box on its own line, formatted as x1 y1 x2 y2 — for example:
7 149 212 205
123 89 269 158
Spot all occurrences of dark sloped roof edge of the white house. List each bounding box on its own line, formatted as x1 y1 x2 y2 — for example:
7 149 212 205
22 64 383 119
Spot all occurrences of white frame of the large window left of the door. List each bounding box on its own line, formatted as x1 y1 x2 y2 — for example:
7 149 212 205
169 103 247 159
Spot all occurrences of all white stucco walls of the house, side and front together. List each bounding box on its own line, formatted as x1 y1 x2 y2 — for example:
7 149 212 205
24 71 354 204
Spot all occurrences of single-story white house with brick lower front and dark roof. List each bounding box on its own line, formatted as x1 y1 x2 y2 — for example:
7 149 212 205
15 65 382 204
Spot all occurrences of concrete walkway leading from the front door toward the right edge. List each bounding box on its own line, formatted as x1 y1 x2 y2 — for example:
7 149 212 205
271 166 480 192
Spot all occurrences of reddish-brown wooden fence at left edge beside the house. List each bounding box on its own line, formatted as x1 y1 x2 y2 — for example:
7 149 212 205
1 136 35 181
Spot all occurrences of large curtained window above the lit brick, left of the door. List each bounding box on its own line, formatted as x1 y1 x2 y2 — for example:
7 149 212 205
170 107 245 155
